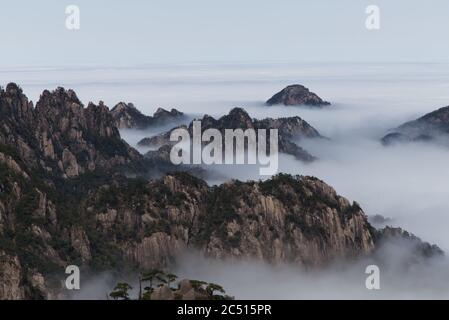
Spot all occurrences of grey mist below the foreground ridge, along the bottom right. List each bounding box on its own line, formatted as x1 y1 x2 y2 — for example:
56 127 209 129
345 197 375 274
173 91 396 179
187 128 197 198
174 240 449 300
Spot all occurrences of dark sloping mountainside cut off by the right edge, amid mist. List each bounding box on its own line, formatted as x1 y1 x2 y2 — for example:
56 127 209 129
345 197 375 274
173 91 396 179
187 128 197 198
382 106 449 145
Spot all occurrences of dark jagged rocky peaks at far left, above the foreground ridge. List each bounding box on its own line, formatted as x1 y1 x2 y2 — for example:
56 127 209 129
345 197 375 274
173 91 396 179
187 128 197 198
0 84 141 177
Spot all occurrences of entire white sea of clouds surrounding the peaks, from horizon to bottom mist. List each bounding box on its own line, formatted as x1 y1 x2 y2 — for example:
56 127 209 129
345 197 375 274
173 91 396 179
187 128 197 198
0 63 449 298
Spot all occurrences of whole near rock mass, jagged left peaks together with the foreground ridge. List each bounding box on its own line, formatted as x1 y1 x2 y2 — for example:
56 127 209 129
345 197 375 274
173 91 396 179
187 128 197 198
0 84 439 299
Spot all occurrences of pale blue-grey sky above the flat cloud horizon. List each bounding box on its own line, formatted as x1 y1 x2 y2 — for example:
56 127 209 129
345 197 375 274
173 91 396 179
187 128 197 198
0 0 449 68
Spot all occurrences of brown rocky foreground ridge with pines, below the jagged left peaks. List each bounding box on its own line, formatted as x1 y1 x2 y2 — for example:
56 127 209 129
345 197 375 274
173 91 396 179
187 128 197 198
0 171 374 298
